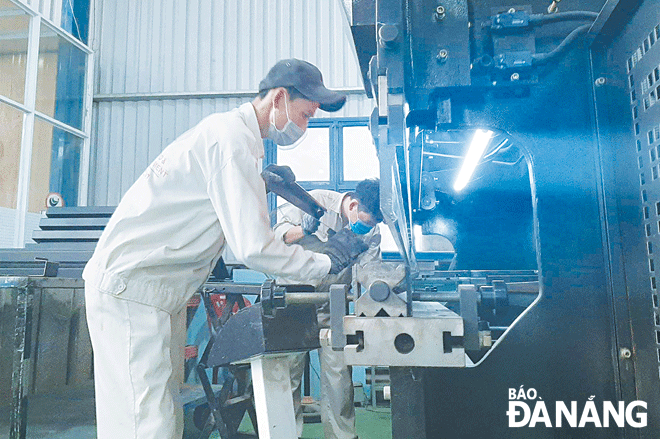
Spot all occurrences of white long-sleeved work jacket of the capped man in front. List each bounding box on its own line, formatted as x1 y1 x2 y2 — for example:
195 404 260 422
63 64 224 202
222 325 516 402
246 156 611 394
83 103 330 313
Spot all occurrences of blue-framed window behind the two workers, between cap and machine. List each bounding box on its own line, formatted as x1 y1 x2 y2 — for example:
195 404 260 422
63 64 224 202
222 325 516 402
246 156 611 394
274 117 380 191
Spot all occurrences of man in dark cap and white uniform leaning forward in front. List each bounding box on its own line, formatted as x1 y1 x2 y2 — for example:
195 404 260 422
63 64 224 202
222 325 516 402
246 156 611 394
83 59 366 439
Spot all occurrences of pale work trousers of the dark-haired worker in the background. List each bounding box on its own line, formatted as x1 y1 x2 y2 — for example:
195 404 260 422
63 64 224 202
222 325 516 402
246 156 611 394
291 330 357 439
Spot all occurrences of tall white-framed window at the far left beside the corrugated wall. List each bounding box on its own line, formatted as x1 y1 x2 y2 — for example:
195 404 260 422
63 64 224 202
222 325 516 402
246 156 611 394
0 0 92 247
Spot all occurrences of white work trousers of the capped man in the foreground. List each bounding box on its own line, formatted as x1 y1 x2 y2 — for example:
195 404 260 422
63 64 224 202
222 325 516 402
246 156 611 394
85 287 186 439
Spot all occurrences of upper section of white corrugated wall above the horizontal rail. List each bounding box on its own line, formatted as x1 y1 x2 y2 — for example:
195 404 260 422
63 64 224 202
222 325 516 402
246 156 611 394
93 0 361 95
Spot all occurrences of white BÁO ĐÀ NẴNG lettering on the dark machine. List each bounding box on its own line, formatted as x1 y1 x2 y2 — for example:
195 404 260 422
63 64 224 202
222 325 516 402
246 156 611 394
506 386 647 428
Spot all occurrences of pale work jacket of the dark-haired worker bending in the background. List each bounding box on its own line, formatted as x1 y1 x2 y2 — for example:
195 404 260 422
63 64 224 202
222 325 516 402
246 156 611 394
273 189 381 265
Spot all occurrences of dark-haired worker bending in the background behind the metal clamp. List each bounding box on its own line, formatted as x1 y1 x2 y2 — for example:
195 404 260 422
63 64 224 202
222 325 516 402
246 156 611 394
274 179 383 439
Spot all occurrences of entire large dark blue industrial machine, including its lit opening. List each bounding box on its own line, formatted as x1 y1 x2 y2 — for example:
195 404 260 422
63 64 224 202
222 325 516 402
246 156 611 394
344 0 660 439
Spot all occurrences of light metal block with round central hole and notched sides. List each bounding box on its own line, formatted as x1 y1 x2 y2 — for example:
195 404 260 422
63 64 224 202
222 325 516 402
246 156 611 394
344 315 465 367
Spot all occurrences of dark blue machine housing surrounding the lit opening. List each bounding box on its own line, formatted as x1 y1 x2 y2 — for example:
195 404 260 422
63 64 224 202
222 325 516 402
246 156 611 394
345 0 660 439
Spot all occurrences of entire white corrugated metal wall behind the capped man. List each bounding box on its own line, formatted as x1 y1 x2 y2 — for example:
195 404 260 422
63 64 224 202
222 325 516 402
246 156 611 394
89 0 373 205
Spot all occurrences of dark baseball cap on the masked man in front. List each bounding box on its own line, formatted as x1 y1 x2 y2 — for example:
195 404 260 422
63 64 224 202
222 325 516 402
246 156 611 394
259 58 346 111
